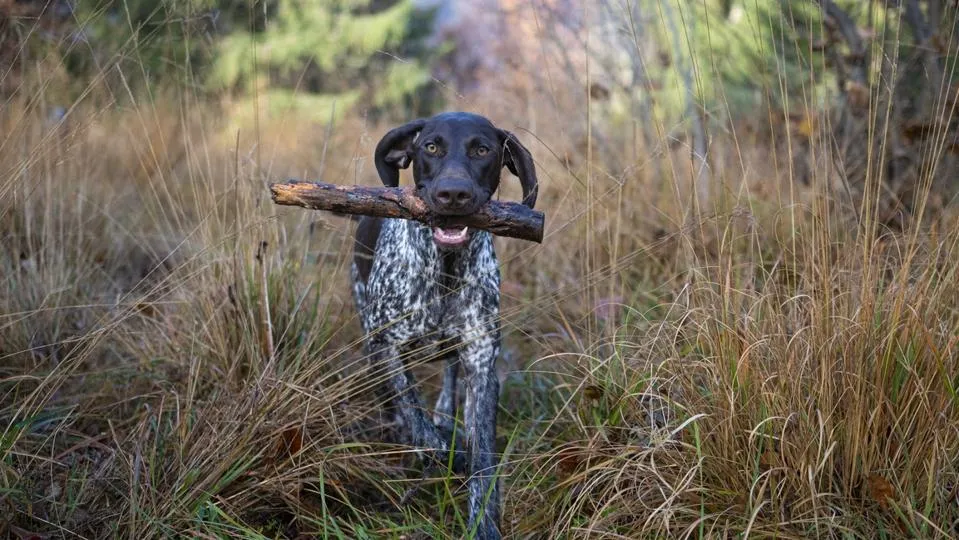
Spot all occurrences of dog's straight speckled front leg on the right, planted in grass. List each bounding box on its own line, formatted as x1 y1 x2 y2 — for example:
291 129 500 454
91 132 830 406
461 329 500 540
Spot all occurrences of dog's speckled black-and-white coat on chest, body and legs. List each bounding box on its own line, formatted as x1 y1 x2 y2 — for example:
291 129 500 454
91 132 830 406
353 219 500 538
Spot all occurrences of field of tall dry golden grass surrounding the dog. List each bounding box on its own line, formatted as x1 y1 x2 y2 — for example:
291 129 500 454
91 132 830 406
0 2 959 538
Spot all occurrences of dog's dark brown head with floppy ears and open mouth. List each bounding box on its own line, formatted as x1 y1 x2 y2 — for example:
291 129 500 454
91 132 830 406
374 112 537 249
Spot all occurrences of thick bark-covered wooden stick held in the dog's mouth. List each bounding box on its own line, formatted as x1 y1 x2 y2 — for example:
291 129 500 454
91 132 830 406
270 180 546 243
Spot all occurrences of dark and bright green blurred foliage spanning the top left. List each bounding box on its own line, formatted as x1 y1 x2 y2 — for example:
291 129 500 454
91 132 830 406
3 0 432 113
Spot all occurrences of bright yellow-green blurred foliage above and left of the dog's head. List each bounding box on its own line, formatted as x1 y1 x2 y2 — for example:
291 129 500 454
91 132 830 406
211 0 431 118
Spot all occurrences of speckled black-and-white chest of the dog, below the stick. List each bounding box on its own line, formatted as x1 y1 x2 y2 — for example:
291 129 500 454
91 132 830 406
362 220 499 341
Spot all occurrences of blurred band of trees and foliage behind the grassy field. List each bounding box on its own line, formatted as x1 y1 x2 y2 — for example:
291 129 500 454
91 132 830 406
9 0 956 221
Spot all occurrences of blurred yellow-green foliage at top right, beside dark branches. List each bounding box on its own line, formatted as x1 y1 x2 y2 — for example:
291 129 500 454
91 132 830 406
609 0 886 125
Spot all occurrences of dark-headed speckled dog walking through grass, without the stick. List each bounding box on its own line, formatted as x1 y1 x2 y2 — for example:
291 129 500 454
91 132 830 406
352 112 537 539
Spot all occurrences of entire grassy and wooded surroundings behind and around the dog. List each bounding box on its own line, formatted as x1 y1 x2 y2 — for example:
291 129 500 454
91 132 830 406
0 0 959 538
